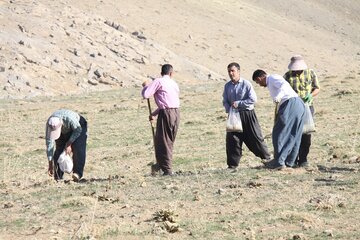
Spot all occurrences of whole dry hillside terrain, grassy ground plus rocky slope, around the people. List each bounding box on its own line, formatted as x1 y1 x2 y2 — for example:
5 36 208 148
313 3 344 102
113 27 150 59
0 0 360 240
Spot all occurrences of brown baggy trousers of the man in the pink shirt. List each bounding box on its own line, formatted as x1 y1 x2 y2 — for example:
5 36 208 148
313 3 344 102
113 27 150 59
155 108 180 173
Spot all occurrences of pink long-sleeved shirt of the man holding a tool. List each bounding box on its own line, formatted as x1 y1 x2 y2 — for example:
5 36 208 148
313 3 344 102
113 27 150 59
141 75 180 116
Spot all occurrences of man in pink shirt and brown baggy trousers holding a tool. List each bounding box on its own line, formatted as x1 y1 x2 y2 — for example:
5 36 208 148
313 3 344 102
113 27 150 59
141 64 180 175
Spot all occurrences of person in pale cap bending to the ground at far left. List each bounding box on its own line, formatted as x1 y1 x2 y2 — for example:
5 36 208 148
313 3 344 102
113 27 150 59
46 109 87 182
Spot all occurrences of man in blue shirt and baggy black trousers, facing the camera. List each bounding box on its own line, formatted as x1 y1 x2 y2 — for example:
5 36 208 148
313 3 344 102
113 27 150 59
223 62 271 169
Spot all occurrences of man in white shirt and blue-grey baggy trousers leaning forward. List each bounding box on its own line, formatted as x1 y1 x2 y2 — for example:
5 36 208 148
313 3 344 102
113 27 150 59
252 69 305 170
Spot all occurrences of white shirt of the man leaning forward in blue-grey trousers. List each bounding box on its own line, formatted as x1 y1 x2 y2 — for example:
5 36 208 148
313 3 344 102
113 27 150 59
266 74 298 106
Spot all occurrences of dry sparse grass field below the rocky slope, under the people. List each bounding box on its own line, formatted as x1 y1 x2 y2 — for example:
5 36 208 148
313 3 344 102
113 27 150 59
0 76 360 239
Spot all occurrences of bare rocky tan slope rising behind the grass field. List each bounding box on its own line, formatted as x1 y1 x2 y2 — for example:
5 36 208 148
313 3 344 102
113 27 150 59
0 0 360 98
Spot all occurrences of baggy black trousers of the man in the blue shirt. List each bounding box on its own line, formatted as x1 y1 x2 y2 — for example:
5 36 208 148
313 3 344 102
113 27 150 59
226 110 270 167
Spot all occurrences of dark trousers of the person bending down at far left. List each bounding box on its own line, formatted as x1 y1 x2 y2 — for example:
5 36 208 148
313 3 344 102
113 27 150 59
54 116 87 179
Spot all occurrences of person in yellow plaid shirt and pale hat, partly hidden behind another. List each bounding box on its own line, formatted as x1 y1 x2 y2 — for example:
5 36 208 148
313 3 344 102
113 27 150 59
284 55 320 167
